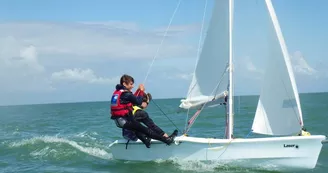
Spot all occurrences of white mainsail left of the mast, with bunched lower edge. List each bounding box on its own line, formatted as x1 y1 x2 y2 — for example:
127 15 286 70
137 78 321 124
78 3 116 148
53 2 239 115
180 0 229 109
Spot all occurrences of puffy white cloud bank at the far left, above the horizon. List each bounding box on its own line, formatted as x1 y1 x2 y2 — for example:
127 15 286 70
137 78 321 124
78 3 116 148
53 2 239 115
0 40 55 93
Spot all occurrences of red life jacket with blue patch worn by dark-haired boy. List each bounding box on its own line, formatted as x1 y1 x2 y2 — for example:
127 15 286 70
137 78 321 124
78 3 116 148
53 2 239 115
110 90 132 117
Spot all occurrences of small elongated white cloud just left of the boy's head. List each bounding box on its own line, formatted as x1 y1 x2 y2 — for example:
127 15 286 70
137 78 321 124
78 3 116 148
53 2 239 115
51 68 120 84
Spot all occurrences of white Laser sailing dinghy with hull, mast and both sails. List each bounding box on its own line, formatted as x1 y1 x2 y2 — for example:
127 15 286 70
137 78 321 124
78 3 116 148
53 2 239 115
110 0 326 170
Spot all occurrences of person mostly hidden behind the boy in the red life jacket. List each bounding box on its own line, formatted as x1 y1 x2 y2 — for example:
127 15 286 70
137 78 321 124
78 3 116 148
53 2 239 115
122 93 178 148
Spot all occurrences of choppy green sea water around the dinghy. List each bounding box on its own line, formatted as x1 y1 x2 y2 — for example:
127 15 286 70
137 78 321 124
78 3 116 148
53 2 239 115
0 93 328 173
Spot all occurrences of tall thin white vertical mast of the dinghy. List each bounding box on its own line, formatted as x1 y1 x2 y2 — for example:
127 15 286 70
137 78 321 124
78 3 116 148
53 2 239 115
227 0 234 139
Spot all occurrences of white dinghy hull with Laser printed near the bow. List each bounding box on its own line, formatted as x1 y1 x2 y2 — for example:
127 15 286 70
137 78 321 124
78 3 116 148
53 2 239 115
111 135 326 170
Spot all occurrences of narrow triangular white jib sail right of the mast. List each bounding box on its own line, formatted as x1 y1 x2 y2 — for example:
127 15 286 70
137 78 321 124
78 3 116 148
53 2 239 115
252 0 303 135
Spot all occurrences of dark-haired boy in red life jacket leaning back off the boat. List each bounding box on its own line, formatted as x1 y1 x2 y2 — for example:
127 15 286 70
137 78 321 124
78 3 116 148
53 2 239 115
111 74 174 148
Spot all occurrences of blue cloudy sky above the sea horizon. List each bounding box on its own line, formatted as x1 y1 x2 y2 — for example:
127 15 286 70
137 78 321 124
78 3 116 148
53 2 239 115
0 0 328 105
